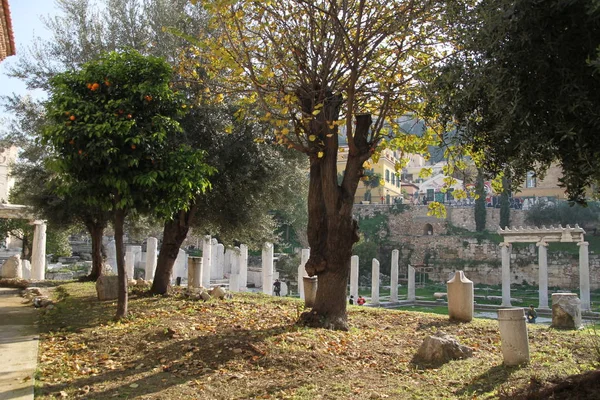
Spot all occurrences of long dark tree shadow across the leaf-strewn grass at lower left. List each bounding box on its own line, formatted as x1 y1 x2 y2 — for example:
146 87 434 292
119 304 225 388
40 325 316 399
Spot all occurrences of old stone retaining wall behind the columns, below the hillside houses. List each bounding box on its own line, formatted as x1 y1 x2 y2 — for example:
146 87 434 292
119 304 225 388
355 205 600 290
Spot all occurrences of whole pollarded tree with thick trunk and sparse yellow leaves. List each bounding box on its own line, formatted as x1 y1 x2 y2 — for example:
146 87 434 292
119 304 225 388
192 0 456 329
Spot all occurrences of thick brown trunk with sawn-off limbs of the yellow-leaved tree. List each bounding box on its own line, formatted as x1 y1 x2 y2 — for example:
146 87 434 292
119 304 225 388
299 89 372 330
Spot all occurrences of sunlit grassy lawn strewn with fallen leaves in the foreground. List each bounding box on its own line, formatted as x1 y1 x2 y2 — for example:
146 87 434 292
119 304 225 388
36 283 600 400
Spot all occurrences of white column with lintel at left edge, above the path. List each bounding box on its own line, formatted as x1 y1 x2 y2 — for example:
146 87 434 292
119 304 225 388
0 204 46 281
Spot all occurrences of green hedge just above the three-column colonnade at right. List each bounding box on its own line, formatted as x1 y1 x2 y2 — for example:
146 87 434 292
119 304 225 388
525 202 600 227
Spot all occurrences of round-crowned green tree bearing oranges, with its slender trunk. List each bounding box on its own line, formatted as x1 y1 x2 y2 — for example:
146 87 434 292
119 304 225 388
42 50 212 318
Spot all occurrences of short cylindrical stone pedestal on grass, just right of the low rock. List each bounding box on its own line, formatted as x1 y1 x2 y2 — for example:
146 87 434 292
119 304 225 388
496 310 529 366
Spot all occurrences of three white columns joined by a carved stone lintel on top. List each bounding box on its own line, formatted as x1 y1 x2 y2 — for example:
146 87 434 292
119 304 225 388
498 225 590 311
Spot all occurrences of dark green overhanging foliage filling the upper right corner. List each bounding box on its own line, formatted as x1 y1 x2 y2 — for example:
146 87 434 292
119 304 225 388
431 0 600 201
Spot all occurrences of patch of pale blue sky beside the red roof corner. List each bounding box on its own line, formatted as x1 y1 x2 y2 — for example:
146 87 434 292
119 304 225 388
0 0 58 101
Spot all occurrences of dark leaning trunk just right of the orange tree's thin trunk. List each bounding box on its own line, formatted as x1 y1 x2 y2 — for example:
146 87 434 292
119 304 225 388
150 205 196 294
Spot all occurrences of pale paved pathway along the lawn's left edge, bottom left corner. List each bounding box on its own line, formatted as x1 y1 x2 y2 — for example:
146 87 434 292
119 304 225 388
0 288 38 400
